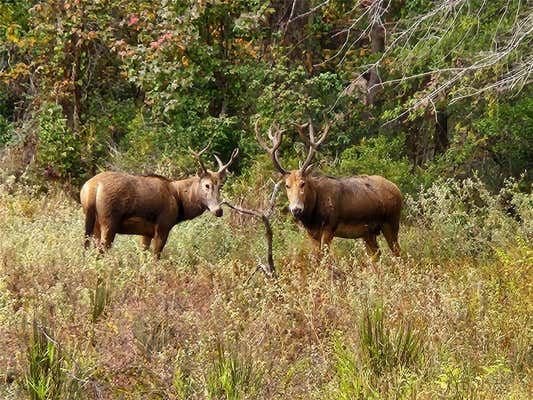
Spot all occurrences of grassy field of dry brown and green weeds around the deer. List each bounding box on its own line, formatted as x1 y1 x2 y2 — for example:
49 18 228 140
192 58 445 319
0 181 533 399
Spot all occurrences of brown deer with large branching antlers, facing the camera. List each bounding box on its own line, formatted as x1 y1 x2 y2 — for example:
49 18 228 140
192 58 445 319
255 120 402 260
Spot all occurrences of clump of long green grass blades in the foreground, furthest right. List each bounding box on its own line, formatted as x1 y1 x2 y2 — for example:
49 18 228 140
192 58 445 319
328 305 426 400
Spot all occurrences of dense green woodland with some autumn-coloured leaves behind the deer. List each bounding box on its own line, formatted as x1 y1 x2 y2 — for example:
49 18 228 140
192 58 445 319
0 0 533 190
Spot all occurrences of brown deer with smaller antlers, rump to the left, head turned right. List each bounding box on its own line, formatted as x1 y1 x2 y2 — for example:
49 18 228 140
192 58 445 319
80 145 239 258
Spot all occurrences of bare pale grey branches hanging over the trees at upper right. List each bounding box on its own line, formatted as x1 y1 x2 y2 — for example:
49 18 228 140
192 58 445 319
324 0 533 118
